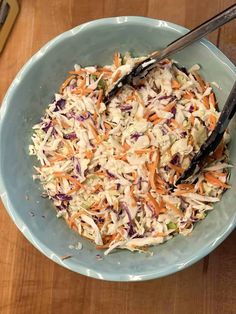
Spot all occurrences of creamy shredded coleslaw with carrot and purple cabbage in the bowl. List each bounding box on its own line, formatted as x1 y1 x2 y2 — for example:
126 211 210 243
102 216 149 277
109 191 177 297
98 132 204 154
29 53 230 255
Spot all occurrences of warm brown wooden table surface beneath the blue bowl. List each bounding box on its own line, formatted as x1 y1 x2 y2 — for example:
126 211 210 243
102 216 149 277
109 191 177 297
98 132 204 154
0 0 236 314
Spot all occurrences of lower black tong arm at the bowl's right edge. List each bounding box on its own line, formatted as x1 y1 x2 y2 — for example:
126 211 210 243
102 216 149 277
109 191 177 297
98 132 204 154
175 82 236 185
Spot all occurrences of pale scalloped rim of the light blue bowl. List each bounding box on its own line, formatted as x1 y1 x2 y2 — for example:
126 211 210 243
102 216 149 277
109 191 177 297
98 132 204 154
0 16 236 281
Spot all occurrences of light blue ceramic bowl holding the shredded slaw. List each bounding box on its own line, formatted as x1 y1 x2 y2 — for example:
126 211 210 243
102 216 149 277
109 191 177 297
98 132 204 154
0 17 236 281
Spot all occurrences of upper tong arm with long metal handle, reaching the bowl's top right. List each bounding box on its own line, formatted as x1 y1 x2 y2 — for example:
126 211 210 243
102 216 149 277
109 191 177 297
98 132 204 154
103 4 236 105
